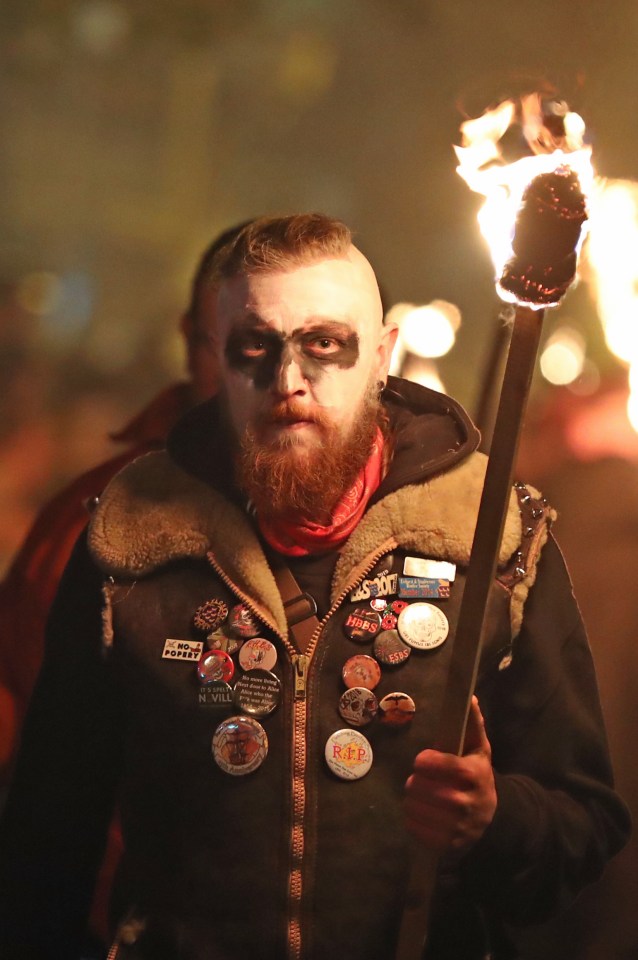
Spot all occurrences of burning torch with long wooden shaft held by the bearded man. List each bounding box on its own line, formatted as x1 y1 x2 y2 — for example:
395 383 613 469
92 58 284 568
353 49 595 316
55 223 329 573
396 94 593 960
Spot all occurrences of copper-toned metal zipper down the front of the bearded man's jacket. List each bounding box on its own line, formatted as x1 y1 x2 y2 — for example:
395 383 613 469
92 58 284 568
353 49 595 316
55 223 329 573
207 543 396 960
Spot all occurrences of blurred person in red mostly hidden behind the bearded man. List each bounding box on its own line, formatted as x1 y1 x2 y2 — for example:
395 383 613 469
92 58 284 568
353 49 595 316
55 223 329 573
0 223 245 948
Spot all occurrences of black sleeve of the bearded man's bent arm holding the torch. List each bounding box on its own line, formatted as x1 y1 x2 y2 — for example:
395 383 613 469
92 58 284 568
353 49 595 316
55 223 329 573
463 538 630 924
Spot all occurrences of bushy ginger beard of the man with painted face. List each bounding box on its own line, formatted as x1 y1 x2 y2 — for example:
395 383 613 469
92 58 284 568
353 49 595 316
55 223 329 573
236 381 386 524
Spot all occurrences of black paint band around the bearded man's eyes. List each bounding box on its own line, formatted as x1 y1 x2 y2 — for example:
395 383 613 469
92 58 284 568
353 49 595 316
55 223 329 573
225 322 359 390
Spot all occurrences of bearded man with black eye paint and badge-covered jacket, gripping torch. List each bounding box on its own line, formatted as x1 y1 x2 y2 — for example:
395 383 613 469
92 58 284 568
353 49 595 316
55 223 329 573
0 214 628 960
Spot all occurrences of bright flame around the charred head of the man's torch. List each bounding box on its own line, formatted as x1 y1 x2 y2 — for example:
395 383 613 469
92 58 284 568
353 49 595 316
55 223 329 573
454 94 594 309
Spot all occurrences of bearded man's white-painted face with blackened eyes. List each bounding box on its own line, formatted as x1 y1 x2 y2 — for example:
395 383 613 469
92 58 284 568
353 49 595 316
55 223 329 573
217 247 394 451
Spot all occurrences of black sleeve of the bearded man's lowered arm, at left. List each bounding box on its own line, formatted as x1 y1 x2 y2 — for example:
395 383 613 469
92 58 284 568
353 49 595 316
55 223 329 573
0 536 123 960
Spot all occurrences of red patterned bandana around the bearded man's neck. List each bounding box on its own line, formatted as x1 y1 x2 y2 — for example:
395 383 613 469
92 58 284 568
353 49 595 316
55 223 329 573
257 427 384 557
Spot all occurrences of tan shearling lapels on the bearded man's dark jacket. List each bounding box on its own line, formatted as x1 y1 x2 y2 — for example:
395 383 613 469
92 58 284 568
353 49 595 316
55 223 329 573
89 452 521 634
